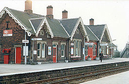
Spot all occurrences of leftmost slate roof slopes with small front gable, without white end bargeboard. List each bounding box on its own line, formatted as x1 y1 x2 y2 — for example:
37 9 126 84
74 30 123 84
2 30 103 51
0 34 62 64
1 7 69 38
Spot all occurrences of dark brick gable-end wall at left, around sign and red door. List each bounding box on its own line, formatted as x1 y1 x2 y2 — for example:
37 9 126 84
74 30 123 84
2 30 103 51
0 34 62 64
0 14 28 63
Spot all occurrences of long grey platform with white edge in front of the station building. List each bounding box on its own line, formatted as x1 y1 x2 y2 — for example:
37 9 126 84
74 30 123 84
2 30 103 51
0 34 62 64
0 58 129 76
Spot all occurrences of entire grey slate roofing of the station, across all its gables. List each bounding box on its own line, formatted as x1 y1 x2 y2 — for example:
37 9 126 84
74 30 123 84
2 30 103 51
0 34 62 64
0 7 110 41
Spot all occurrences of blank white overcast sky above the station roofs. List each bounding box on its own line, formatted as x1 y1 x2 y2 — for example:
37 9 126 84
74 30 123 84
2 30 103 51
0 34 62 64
0 0 129 50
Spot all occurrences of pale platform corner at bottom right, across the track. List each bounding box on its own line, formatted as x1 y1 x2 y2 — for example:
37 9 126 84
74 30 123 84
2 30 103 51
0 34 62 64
80 71 129 84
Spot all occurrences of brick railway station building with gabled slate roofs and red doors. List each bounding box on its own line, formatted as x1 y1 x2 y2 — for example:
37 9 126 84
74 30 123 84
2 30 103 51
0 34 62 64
0 0 115 64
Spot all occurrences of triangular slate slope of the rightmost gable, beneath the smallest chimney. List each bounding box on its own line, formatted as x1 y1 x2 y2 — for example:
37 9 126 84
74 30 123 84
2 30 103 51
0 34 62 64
87 25 105 40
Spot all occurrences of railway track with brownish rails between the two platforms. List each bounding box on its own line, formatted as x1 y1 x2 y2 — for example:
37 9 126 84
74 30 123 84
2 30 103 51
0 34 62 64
21 66 129 84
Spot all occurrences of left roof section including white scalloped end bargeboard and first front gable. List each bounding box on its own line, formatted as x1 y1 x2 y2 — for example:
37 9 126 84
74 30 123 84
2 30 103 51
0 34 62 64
0 7 69 38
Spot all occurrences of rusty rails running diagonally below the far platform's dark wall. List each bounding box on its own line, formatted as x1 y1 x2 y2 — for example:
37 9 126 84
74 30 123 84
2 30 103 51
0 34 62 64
20 66 129 84
